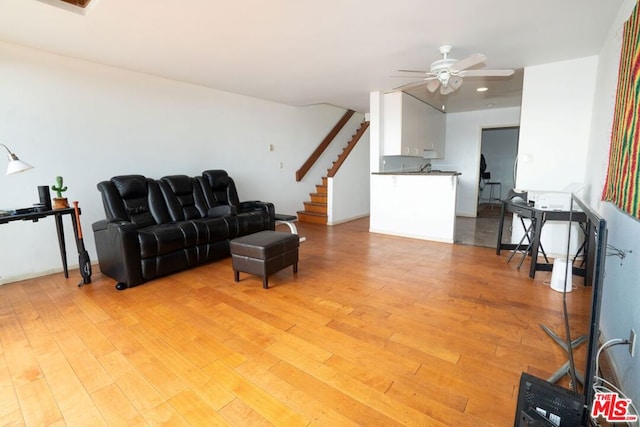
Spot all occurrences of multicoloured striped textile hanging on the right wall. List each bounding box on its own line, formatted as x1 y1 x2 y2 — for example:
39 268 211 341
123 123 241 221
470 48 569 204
602 3 640 219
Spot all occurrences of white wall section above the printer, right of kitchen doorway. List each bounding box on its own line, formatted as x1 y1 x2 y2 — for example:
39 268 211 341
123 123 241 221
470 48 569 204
516 56 598 191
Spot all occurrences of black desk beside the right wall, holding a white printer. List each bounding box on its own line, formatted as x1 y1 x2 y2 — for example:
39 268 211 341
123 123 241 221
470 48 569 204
496 199 587 279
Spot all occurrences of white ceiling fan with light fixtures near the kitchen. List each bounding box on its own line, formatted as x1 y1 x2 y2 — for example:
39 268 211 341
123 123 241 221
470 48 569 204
394 45 514 95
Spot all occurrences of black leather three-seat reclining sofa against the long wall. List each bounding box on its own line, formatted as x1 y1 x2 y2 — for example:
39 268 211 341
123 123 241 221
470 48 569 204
92 170 275 290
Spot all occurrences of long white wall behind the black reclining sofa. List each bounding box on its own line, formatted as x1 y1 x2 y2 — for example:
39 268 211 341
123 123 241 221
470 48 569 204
0 42 348 283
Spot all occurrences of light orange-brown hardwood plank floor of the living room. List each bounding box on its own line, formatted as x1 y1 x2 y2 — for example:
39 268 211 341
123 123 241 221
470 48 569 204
0 219 590 426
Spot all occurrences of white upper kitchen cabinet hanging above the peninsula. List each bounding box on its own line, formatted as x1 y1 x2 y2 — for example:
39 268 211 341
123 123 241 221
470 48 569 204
383 92 445 158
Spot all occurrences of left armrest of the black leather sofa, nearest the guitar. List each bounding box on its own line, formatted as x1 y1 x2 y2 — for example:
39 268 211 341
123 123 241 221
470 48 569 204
92 219 144 287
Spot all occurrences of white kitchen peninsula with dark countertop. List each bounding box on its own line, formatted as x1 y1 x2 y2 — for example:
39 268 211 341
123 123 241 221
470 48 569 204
369 170 460 243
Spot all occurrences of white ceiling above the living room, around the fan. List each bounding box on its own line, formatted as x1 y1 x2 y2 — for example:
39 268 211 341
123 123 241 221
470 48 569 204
0 0 622 112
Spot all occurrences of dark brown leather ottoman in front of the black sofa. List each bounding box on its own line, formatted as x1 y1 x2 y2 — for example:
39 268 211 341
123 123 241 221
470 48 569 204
229 230 300 289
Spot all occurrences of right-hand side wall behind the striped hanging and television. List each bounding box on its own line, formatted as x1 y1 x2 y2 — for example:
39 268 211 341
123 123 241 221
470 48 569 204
584 0 640 407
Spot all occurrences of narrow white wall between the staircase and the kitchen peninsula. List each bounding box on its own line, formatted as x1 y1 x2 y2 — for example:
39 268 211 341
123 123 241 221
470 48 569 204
327 130 370 225
